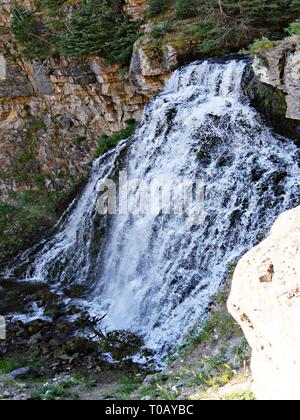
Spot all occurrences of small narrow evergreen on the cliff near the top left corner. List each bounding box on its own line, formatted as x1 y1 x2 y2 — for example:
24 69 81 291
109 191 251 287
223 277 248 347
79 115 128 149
11 4 55 60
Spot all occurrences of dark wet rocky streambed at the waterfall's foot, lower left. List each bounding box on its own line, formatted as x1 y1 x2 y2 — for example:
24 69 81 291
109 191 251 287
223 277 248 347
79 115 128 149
0 278 151 392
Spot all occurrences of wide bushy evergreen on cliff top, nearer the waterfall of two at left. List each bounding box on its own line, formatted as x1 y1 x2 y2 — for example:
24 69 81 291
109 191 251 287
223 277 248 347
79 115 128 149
60 0 140 65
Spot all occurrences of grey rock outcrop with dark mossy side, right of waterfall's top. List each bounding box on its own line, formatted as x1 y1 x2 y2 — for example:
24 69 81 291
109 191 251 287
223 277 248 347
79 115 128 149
245 36 300 140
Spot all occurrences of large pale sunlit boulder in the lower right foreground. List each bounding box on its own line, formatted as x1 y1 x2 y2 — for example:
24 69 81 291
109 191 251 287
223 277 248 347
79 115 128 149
228 207 300 400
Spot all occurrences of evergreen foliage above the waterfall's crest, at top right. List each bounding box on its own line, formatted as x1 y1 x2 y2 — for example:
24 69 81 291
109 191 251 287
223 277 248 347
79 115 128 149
184 0 300 55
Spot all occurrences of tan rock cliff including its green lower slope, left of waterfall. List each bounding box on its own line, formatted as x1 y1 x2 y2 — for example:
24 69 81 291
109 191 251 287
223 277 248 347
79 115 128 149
0 0 178 266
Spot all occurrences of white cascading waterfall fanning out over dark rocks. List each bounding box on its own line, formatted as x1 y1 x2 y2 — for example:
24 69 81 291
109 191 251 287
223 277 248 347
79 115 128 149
6 60 300 358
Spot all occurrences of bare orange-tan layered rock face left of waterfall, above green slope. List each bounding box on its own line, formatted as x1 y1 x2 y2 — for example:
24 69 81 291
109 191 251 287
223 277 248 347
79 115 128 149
0 0 174 202
